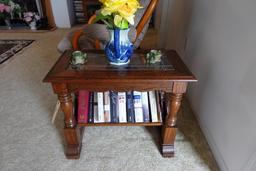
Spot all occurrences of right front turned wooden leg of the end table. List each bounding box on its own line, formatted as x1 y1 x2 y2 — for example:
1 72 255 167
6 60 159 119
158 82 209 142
162 93 182 157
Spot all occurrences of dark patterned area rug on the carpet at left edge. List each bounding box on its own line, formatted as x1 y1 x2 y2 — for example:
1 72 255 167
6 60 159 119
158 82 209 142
0 40 34 64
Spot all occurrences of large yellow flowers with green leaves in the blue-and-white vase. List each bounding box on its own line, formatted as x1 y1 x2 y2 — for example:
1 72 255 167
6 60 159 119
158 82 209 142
94 0 142 29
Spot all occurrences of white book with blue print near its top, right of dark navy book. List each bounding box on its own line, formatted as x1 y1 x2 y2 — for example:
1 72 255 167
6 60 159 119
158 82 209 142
133 91 143 122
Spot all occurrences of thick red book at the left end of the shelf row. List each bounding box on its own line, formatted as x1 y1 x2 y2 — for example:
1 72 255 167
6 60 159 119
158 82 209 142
78 90 89 123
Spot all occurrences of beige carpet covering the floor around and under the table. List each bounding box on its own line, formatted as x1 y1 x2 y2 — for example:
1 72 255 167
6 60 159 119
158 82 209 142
0 30 218 171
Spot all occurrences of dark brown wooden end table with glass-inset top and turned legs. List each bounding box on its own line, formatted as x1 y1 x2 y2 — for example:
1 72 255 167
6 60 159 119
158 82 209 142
43 50 197 159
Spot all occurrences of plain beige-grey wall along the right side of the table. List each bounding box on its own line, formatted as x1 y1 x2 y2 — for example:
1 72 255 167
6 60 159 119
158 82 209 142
157 0 256 171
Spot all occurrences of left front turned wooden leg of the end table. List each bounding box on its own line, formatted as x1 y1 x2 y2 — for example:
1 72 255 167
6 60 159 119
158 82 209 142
53 84 83 159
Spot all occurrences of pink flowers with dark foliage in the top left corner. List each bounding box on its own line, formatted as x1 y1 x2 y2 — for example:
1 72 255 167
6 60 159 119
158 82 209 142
0 0 21 19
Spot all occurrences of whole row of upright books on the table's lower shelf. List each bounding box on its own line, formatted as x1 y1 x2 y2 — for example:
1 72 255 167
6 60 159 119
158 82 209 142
77 90 162 123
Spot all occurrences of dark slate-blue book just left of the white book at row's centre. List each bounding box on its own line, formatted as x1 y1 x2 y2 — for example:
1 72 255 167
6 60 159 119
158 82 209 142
110 91 119 123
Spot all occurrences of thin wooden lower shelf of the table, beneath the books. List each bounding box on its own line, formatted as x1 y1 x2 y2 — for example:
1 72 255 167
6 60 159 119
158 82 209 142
78 122 163 126
